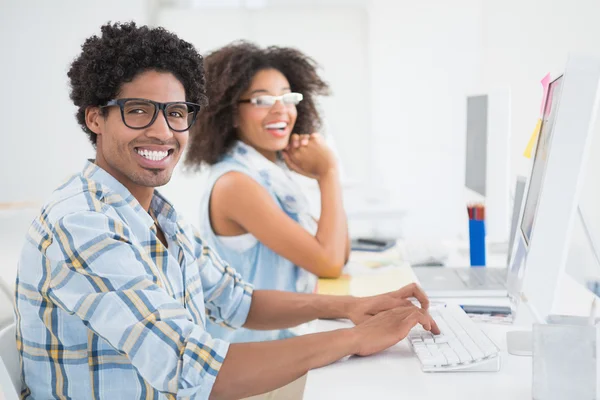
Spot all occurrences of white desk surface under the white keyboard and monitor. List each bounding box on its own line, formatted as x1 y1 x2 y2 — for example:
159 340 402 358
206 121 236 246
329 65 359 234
304 241 590 400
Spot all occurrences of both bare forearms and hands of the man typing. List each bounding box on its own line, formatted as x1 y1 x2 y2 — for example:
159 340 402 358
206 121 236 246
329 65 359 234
212 284 439 399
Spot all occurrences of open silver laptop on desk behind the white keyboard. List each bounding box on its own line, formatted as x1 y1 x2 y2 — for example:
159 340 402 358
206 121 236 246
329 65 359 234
413 177 526 297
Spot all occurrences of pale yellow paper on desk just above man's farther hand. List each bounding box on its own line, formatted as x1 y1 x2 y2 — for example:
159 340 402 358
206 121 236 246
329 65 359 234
350 266 417 297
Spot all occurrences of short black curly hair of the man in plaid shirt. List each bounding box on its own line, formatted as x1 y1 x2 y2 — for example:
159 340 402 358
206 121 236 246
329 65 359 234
67 22 206 146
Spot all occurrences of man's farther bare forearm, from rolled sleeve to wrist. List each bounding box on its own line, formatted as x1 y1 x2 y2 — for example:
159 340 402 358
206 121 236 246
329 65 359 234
244 290 353 330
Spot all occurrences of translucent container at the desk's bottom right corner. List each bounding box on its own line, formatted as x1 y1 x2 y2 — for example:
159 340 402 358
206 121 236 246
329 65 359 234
533 316 600 400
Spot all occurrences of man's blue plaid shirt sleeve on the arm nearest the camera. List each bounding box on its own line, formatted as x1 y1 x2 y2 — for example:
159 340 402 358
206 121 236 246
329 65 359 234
45 211 233 399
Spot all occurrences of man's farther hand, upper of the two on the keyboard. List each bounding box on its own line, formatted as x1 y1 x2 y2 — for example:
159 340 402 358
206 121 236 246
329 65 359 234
348 283 429 325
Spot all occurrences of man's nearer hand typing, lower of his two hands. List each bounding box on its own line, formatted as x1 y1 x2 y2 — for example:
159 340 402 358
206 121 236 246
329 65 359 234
352 304 440 356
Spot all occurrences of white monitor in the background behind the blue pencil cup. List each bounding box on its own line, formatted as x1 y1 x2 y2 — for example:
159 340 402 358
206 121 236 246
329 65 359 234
465 90 511 242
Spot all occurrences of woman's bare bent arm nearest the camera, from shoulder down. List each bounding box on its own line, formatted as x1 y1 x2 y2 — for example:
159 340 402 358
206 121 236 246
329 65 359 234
210 172 347 278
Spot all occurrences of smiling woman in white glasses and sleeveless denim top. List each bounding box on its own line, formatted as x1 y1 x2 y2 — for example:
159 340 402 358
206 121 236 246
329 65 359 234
186 42 350 341
